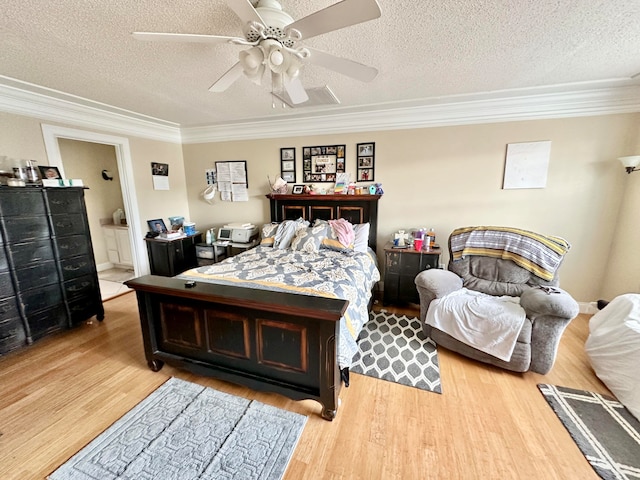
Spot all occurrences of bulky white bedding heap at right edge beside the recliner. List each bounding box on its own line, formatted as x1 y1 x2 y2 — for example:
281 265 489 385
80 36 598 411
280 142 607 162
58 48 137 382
585 293 640 420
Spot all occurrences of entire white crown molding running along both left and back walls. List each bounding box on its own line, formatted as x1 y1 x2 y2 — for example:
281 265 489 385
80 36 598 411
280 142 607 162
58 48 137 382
0 76 640 144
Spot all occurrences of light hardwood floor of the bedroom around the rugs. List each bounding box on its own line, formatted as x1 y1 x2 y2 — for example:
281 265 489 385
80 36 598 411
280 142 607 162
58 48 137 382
0 293 608 480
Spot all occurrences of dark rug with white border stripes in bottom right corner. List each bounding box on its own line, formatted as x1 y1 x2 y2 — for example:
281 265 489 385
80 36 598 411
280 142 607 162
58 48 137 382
538 384 640 480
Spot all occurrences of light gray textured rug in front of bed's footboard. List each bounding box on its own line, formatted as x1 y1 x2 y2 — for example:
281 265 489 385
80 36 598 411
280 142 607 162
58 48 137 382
48 378 307 480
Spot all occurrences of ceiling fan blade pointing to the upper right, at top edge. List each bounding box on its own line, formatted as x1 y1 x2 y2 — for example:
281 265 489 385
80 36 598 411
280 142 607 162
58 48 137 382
288 0 382 39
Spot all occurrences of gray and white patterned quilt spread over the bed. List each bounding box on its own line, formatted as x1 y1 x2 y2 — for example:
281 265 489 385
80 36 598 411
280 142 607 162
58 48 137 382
178 246 380 368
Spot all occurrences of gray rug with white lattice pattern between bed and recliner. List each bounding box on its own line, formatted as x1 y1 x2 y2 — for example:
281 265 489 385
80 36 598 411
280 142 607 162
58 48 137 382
350 312 442 393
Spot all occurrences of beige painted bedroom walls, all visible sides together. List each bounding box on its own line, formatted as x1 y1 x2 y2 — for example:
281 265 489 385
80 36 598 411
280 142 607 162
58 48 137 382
0 113 640 302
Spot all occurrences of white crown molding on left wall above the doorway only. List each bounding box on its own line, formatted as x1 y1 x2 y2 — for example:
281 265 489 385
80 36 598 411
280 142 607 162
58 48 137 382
0 77 182 143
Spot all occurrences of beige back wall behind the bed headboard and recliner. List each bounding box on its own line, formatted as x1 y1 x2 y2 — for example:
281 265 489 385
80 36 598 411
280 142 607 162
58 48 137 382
183 114 640 302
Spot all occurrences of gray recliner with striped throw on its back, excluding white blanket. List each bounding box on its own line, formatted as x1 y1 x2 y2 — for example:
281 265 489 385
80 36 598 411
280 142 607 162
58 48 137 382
415 227 579 374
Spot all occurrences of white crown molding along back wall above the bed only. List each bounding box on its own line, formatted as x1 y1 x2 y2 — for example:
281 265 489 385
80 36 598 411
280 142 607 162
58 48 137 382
181 85 640 144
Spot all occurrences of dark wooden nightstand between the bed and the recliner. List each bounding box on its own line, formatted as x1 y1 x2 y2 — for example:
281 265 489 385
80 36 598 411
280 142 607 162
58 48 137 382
382 243 440 304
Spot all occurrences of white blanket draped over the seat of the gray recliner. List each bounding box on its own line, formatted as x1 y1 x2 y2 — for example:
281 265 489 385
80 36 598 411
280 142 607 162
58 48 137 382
425 288 526 362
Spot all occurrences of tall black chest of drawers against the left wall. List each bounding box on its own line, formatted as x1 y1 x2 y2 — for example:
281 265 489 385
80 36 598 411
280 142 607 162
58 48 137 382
0 187 104 354
